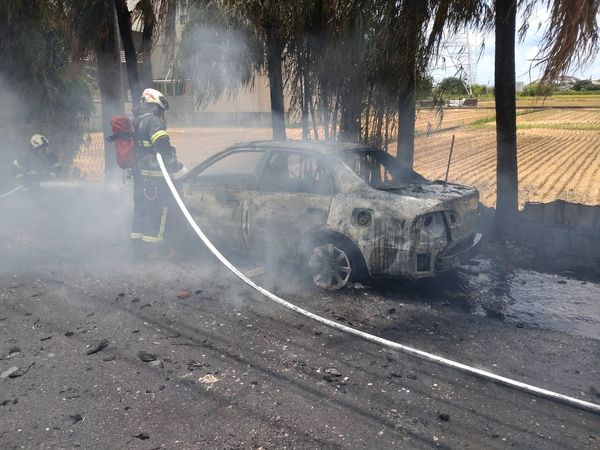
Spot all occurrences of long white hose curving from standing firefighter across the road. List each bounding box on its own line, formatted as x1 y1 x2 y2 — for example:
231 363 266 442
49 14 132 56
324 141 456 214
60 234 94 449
156 153 600 414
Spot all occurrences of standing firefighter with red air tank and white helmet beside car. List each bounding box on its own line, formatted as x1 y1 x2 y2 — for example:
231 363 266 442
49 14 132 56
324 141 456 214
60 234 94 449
131 89 183 257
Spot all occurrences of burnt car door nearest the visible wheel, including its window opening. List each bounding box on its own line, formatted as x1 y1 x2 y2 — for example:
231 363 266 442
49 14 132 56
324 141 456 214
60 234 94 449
242 150 335 257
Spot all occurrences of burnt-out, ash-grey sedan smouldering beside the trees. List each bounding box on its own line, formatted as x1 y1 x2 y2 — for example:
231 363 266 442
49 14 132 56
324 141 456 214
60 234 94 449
178 141 481 289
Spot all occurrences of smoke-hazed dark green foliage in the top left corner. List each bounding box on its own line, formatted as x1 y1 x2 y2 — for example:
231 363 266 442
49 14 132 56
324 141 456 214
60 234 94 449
0 0 93 169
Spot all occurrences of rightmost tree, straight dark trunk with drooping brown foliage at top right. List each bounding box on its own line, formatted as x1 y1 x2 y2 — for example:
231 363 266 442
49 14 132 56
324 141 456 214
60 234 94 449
494 0 600 238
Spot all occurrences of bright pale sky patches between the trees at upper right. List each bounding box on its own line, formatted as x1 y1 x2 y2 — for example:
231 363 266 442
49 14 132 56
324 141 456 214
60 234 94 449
433 8 600 86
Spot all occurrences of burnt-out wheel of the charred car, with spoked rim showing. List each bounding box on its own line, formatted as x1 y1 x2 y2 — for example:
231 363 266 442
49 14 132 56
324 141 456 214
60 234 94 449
304 237 365 291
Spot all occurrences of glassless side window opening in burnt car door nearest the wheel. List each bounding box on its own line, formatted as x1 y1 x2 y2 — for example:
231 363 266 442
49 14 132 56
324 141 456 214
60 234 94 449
260 152 333 195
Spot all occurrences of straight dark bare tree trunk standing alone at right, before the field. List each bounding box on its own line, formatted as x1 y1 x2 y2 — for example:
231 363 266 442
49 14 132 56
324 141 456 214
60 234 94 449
494 0 519 237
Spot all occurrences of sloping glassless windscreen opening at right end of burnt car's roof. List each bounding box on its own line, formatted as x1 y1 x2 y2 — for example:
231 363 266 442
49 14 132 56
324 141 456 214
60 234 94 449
342 150 426 189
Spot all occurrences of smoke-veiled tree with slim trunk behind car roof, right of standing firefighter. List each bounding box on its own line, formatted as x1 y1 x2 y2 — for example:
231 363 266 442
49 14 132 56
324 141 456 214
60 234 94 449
182 0 294 140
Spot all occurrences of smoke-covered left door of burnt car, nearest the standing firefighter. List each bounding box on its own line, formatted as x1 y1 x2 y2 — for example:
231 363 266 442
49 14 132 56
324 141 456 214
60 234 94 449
182 149 266 248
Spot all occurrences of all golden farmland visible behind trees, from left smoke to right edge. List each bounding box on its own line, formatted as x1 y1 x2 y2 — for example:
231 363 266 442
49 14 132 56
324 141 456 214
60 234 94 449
74 108 600 207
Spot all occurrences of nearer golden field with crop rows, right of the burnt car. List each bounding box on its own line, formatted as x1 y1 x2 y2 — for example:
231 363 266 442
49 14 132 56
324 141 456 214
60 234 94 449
410 127 600 207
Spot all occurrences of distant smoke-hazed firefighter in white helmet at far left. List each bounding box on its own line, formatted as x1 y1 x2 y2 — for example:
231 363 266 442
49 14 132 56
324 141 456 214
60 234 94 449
13 134 61 189
